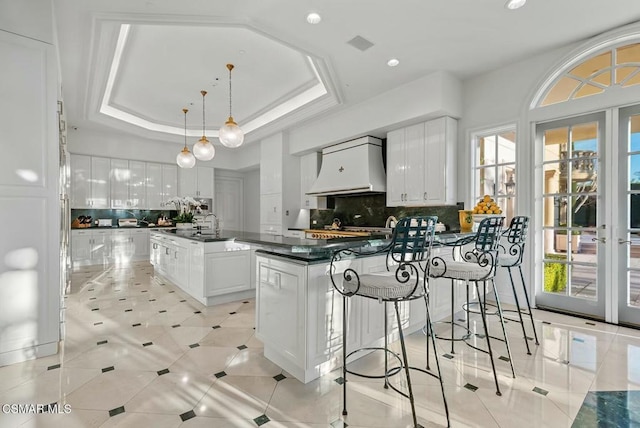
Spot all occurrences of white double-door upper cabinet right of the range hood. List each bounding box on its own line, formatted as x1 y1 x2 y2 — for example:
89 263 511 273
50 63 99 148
387 117 457 206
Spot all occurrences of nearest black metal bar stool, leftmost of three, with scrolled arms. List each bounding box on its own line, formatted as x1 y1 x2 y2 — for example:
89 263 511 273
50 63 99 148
331 217 450 427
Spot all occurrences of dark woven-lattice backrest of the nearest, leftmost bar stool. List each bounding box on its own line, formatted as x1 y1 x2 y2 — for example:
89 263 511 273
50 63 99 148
389 216 438 263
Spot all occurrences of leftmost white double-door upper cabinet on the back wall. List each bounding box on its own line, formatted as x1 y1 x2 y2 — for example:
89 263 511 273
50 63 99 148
71 155 111 208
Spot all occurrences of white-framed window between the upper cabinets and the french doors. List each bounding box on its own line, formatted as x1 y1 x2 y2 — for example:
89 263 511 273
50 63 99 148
473 127 516 224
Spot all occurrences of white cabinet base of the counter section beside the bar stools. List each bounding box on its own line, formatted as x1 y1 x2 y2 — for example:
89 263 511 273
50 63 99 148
256 253 425 383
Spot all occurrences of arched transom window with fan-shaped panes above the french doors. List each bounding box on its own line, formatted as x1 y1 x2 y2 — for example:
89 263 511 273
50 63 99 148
540 43 640 107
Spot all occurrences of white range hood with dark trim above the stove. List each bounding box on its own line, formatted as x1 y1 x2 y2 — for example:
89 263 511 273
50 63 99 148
307 136 387 196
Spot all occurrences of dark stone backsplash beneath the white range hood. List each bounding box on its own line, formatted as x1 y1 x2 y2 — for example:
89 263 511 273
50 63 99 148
310 194 464 230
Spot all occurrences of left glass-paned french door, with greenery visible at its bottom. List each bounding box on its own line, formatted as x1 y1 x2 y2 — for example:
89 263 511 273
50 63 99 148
536 113 613 320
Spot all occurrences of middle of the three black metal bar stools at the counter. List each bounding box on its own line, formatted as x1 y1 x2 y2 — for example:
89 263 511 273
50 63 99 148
429 217 516 395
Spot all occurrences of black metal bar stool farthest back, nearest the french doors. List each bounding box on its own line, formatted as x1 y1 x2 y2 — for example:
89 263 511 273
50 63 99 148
498 216 540 355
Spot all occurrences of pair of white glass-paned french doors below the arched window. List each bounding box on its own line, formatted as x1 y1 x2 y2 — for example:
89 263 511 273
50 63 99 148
536 106 640 326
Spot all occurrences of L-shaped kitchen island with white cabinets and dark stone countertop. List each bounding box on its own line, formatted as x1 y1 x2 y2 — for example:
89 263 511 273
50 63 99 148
151 230 462 383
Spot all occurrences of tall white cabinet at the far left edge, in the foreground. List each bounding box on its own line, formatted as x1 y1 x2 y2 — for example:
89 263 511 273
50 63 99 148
0 15 61 366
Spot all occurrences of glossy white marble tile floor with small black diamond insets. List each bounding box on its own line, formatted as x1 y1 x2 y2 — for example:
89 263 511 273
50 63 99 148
6 262 640 428
